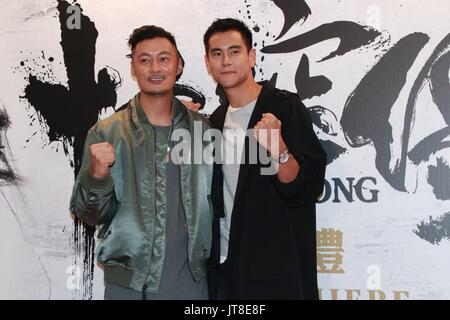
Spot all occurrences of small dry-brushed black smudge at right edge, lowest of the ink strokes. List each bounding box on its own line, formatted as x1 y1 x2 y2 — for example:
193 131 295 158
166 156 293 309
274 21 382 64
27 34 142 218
413 212 450 245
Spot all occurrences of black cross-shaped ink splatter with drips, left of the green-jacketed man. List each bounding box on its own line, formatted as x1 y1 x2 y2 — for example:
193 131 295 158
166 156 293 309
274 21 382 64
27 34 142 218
24 0 121 299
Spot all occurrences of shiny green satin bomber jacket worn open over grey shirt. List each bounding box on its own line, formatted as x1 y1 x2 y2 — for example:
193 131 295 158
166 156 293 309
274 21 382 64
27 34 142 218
70 94 212 292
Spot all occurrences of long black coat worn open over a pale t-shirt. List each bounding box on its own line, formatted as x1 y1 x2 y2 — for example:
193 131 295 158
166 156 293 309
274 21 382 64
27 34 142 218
208 82 326 299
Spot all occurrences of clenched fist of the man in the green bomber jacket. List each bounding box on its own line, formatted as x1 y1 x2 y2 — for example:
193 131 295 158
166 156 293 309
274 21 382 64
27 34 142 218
90 142 116 179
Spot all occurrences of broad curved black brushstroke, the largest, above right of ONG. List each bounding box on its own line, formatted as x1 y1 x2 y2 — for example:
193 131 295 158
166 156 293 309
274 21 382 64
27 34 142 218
341 33 429 191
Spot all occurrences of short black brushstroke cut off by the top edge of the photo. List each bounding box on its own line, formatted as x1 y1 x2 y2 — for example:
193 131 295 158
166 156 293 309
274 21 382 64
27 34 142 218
272 0 311 40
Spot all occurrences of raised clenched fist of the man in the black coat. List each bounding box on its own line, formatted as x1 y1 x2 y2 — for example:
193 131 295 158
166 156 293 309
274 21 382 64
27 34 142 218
253 113 286 161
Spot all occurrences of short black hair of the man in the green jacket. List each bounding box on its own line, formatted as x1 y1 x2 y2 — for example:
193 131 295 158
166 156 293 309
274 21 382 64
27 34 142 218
127 25 185 80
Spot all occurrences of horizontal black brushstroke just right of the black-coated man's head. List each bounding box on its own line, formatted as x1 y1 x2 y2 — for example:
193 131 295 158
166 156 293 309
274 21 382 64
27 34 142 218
261 21 381 62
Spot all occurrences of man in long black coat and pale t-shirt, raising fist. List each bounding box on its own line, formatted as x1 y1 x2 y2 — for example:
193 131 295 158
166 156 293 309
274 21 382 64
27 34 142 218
204 18 326 299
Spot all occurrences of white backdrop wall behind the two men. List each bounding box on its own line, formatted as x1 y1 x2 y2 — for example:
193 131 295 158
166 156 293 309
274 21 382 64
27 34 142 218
0 0 450 299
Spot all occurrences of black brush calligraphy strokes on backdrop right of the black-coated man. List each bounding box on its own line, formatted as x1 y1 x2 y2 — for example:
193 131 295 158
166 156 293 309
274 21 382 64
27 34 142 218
253 1 450 248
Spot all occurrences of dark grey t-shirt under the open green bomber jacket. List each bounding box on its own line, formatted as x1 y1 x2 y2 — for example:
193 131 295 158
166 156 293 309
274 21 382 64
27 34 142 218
105 126 208 300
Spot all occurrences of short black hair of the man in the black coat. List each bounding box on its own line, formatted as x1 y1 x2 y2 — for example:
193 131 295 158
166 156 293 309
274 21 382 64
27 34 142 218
203 18 253 54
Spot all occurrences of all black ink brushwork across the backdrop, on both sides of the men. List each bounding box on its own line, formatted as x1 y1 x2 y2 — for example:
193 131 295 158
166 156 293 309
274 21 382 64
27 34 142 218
12 0 450 298
